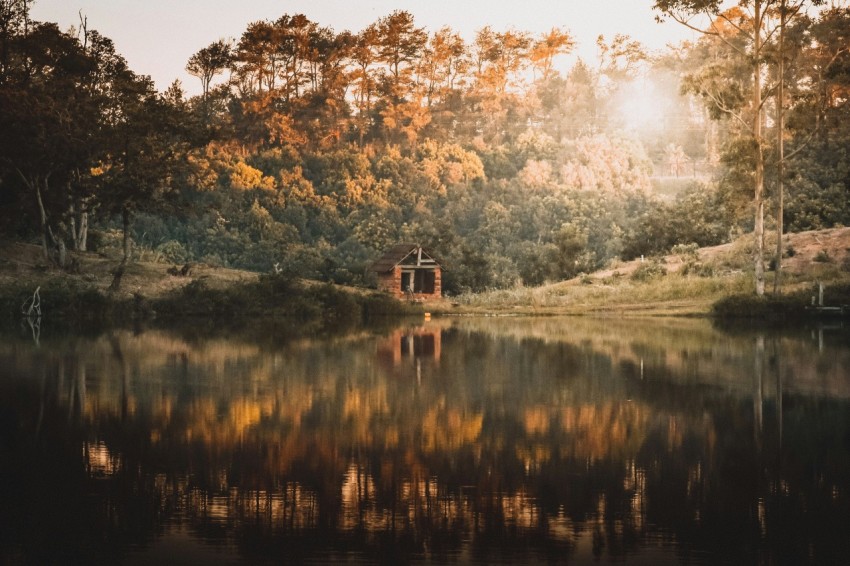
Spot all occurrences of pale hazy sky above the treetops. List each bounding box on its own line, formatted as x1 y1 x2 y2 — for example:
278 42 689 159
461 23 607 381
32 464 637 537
31 0 692 94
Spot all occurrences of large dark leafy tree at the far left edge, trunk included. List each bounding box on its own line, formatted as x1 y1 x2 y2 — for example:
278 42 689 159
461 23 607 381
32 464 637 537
0 19 100 267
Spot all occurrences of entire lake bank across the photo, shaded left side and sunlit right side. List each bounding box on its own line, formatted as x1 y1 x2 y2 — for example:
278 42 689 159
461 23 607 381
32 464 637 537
0 228 850 324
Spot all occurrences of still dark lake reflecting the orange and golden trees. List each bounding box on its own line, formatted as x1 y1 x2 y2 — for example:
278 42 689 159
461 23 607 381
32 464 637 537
0 318 850 564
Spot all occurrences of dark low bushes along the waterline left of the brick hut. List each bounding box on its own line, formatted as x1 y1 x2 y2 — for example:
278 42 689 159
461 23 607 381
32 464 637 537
0 274 422 328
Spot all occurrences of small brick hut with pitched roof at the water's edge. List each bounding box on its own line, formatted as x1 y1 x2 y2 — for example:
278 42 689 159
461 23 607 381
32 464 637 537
369 244 442 300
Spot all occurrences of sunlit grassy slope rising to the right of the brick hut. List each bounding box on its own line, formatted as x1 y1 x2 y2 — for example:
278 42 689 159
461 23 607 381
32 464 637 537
444 228 850 316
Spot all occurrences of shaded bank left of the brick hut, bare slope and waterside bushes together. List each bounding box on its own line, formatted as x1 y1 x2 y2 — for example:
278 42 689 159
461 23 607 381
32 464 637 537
0 242 423 328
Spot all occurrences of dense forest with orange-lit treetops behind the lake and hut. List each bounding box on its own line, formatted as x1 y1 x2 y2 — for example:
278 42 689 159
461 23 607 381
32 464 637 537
0 0 850 295
